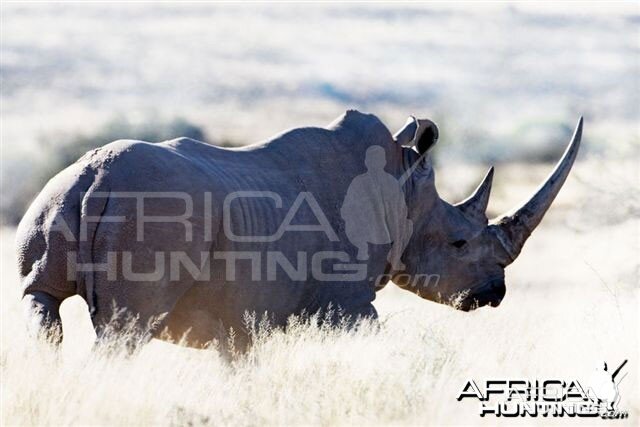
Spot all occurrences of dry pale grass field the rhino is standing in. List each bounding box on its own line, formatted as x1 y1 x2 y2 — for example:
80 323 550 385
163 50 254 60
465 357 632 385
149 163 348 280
0 162 640 425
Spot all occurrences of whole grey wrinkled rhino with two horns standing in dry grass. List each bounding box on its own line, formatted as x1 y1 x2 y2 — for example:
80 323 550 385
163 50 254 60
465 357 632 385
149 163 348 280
17 111 581 352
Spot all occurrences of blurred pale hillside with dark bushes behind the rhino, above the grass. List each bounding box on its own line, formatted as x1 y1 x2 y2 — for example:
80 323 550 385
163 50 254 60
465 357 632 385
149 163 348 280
0 2 640 225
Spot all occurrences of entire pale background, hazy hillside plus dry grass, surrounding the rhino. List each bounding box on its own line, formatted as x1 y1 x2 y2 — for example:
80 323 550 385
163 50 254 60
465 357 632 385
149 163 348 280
0 2 640 425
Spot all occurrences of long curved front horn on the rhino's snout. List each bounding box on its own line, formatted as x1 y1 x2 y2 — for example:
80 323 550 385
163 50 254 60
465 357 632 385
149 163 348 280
493 117 583 261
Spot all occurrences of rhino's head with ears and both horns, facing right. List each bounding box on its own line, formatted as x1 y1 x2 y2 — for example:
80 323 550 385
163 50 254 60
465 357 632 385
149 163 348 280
393 118 582 311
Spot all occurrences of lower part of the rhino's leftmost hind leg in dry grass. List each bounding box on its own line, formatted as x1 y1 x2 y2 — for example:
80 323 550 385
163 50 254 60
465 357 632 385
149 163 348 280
22 291 62 345
